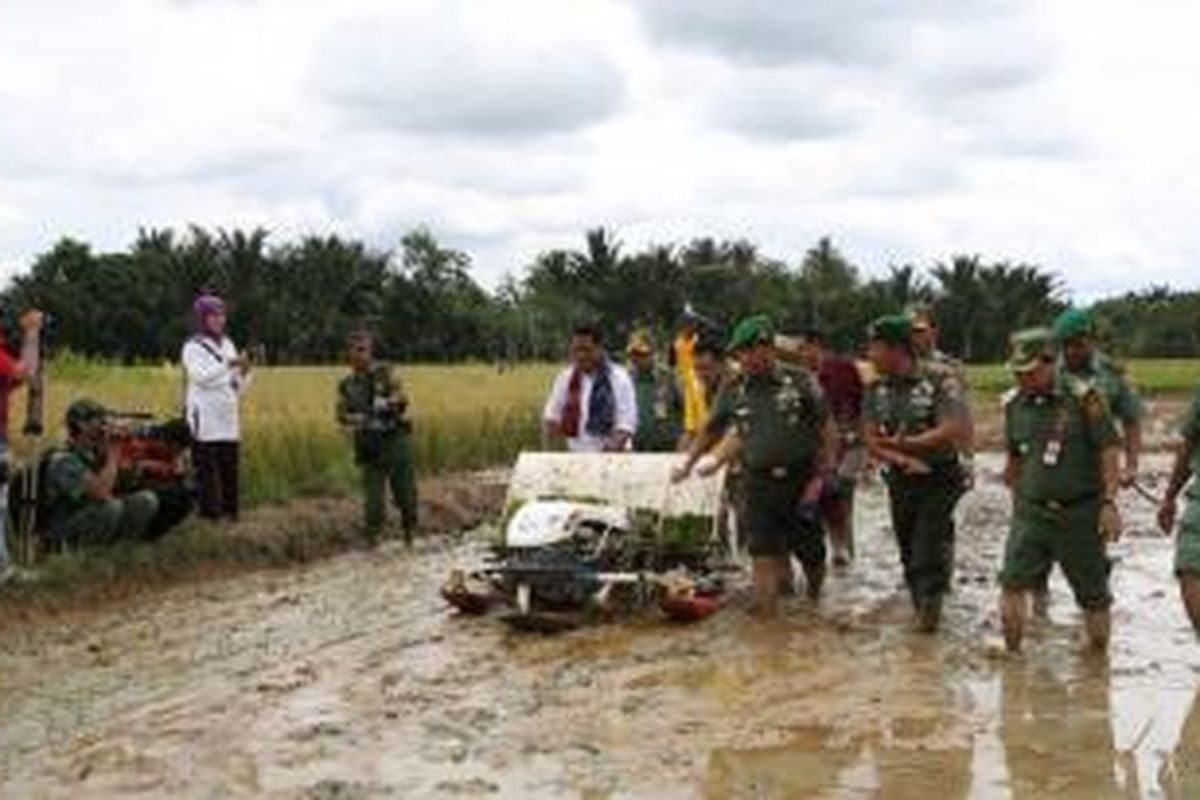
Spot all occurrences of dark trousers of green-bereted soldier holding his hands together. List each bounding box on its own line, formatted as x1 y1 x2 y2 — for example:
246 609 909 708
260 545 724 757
888 465 962 606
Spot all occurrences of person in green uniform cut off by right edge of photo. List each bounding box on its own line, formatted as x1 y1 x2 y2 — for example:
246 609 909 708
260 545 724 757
1158 381 1200 636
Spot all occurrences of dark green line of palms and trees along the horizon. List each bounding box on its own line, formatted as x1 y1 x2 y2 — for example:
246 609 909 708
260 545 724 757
2 227 1200 363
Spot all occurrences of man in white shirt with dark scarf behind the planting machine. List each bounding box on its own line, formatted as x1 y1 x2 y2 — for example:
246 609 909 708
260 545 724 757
542 325 637 452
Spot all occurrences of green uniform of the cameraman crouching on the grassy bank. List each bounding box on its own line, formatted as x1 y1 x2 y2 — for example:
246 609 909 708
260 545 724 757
46 443 158 545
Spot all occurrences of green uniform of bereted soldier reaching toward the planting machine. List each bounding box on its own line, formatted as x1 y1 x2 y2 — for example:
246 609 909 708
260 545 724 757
708 365 829 565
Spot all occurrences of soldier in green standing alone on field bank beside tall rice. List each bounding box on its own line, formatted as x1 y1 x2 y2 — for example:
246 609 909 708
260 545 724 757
337 333 416 545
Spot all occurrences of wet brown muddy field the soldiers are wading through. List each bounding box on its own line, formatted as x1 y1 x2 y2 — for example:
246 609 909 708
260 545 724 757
0 457 1200 799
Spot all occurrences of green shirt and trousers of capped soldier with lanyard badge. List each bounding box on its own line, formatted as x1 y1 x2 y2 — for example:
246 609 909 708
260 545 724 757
1001 373 1117 609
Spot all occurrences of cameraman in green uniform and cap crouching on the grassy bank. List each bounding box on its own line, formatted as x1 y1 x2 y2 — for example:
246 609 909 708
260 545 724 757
44 399 158 545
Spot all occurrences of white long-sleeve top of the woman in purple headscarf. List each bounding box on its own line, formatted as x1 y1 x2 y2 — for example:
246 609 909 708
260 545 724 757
182 336 250 441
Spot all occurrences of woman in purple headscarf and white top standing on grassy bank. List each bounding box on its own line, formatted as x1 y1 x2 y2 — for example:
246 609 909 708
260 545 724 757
182 295 250 521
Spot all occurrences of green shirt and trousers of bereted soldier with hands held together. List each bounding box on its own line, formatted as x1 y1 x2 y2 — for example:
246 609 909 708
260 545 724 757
863 361 966 607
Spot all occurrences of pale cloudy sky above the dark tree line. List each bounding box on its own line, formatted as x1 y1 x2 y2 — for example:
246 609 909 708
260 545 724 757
0 0 1200 299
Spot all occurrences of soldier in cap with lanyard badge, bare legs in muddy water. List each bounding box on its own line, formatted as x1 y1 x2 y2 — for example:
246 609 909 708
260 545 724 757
1000 327 1121 652
